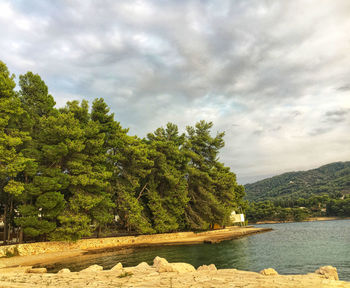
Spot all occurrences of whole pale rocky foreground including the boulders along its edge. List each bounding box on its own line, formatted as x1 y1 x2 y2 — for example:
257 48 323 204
0 257 350 288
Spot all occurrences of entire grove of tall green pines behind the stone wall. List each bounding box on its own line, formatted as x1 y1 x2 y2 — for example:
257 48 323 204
0 61 244 242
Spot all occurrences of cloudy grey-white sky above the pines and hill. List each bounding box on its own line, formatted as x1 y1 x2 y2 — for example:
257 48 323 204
0 0 350 184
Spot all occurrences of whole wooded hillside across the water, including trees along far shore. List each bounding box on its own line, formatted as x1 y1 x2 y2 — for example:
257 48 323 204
245 162 350 222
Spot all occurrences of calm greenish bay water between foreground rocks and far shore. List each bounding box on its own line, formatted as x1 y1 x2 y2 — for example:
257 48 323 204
46 220 350 281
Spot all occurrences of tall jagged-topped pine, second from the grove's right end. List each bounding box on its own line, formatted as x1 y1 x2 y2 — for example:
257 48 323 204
185 121 226 229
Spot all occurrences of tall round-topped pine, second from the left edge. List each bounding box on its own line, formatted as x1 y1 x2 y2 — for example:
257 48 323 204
16 72 61 240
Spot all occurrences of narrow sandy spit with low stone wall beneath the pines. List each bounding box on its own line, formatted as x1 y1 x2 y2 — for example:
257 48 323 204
0 226 273 268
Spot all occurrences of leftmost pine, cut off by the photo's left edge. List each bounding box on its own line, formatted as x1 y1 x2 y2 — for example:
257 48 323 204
0 61 30 242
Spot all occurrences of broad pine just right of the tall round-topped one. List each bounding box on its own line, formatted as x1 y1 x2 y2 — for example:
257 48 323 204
51 101 113 240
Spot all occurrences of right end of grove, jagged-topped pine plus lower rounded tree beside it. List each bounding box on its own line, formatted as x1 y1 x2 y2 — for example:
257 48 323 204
185 121 244 229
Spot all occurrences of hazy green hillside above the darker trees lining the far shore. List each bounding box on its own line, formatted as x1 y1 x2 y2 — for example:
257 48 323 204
245 161 350 201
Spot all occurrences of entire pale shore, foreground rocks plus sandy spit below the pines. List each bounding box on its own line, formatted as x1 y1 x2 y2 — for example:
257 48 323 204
0 227 350 288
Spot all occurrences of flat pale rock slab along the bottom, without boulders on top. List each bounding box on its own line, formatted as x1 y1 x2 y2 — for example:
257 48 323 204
0 263 350 288
